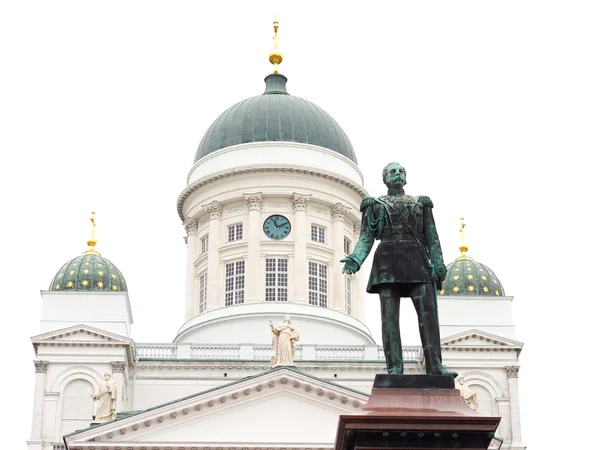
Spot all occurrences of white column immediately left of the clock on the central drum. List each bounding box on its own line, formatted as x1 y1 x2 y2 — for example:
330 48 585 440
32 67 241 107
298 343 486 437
244 192 264 303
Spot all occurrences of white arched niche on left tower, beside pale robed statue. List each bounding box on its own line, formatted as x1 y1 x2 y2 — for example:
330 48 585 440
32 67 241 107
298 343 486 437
61 379 95 435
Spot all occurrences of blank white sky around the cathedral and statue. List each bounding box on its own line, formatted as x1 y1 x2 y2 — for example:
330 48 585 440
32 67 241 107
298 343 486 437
0 1 600 449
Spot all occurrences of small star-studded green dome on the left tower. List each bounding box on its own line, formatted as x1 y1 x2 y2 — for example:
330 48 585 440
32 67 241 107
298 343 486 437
49 252 127 292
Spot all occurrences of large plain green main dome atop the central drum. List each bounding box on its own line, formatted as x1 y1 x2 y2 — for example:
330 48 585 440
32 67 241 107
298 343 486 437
194 74 356 163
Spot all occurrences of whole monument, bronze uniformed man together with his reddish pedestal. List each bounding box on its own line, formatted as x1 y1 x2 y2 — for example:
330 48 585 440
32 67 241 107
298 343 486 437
335 163 500 450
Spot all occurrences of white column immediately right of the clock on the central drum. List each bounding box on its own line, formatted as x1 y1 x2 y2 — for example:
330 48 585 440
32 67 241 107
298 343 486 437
290 192 310 303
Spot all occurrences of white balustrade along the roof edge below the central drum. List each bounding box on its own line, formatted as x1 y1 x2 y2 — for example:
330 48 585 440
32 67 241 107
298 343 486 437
136 344 423 362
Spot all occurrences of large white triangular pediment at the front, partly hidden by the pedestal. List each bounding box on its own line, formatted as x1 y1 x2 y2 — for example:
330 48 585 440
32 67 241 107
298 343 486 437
65 368 368 450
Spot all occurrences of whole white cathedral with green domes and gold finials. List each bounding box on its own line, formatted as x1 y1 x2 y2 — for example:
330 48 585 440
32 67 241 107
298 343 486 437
28 23 525 450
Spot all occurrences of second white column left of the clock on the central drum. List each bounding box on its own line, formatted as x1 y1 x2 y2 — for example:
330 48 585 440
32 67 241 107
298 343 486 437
204 200 225 310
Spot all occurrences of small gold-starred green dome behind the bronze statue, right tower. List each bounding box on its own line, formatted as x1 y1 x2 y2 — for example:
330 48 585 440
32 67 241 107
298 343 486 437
439 257 504 297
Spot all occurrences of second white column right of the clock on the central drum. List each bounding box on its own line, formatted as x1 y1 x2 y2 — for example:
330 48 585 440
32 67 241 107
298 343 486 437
331 203 348 312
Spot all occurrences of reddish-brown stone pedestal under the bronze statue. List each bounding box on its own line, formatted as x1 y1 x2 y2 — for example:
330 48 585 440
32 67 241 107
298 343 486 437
335 375 500 450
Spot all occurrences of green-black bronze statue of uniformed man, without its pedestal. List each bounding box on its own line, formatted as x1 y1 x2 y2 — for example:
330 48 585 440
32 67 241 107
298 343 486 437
342 163 457 376
